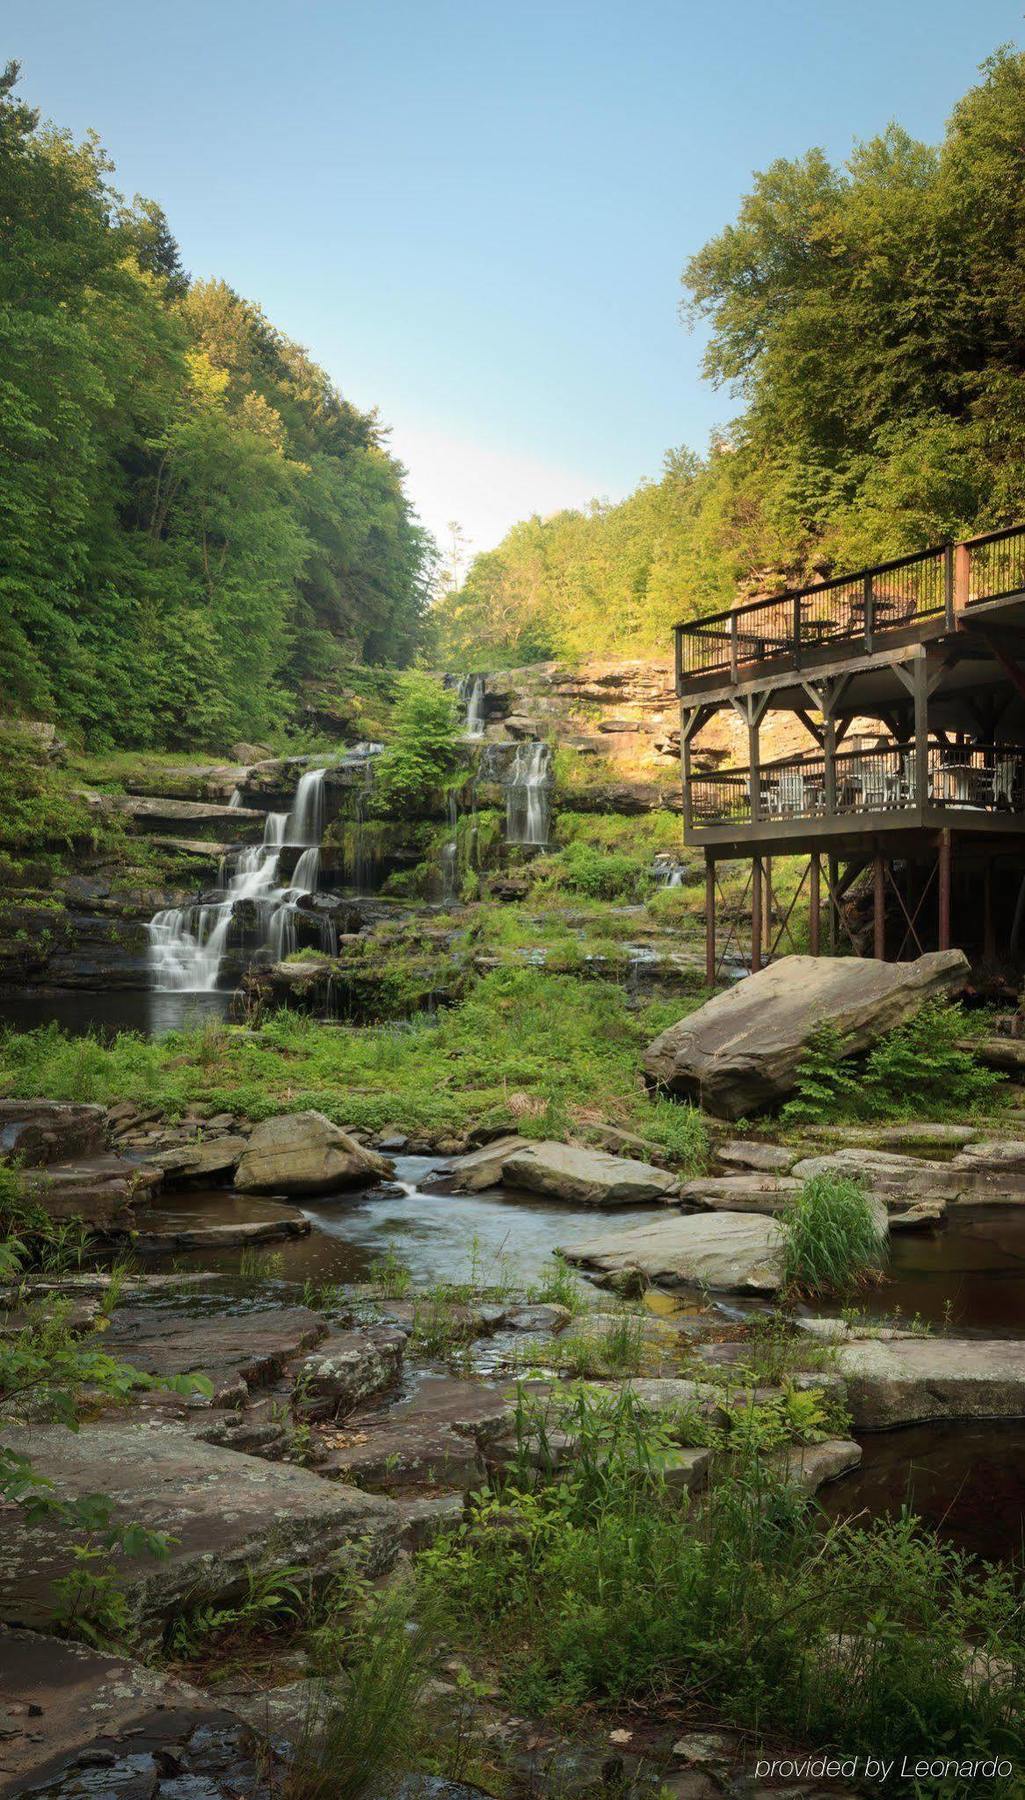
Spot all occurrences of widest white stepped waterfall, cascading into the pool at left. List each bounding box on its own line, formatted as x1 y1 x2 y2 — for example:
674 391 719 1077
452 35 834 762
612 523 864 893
150 769 324 994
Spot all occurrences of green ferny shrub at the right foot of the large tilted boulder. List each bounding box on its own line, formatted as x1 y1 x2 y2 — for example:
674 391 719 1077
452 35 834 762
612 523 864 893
782 1001 1007 1125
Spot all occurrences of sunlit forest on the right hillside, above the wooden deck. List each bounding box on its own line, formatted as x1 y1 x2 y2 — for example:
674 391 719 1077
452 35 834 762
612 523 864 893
438 50 1025 668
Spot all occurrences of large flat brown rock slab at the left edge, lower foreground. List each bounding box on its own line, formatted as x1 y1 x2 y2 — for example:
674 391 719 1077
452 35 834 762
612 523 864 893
0 1420 400 1634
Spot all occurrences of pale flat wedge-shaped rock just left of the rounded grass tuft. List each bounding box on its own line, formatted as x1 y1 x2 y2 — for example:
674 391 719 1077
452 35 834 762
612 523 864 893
562 1213 782 1294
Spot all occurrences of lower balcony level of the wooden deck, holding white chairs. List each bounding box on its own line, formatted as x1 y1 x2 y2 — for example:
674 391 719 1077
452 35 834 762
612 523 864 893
688 742 1025 848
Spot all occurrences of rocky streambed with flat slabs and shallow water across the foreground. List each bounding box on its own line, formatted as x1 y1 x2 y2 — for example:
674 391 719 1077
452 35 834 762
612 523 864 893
0 1102 1025 1800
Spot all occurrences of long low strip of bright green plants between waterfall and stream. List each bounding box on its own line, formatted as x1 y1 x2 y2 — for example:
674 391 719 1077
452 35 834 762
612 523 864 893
0 968 706 1170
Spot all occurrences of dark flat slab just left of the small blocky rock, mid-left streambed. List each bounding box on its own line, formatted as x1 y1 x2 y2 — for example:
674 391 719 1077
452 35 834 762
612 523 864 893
103 1305 328 1404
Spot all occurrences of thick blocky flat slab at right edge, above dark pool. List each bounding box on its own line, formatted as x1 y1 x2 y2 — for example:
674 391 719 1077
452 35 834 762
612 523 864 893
834 1336 1025 1431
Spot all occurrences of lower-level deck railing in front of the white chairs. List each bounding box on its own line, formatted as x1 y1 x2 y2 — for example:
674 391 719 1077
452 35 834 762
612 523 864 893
690 743 1025 828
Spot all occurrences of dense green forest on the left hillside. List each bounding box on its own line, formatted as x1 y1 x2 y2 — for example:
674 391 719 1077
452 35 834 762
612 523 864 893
0 65 431 745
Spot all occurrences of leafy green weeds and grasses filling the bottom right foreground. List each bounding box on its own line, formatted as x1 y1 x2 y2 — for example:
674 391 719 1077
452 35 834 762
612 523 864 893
420 1391 1025 1778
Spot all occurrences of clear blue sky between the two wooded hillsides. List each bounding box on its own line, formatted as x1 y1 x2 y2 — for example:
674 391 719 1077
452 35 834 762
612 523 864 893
0 0 1021 549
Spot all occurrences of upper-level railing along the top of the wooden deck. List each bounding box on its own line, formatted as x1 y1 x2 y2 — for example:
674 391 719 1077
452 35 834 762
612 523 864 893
676 526 1025 693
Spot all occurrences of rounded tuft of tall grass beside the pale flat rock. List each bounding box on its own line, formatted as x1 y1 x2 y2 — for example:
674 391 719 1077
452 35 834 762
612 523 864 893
780 1172 886 1296
